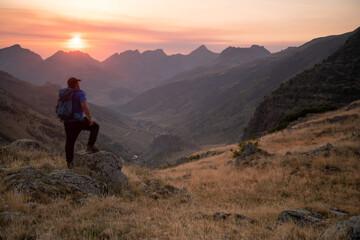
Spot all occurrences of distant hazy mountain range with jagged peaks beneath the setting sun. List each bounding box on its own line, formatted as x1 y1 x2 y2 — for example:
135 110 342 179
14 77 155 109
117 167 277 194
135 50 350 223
0 44 270 106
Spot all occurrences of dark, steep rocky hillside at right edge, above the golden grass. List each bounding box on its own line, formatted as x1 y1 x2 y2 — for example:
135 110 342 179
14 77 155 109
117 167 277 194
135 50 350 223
243 30 360 139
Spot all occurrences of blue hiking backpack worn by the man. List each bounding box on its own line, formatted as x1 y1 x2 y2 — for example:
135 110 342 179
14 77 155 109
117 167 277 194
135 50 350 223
56 88 76 121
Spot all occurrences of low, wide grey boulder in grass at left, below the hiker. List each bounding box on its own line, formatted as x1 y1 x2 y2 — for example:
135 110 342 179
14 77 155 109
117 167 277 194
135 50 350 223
2 166 107 201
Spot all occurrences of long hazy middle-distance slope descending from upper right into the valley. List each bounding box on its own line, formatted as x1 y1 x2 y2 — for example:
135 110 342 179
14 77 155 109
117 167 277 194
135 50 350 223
118 28 352 144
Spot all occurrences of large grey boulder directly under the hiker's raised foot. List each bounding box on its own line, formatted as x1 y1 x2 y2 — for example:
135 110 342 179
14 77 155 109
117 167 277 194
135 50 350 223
74 151 127 190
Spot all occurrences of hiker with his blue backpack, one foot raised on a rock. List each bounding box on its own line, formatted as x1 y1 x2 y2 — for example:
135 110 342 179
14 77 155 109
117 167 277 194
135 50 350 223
56 77 99 169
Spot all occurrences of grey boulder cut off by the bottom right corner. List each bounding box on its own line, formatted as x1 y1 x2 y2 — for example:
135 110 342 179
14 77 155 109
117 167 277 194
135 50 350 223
319 216 360 240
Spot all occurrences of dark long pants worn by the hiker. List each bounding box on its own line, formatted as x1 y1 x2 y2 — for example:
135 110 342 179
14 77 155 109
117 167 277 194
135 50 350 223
64 118 99 163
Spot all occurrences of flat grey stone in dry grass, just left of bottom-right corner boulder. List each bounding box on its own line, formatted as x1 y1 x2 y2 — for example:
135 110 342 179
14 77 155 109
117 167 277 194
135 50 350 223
277 208 325 227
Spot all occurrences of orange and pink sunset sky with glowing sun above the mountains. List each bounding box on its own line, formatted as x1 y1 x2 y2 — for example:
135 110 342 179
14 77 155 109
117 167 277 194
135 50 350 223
0 0 360 61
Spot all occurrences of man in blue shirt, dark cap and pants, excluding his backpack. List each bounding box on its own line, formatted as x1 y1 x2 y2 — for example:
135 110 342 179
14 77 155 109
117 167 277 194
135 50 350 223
64 77 99 169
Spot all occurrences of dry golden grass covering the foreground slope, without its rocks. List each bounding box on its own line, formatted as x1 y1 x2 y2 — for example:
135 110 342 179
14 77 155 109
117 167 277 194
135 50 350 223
0 101 360 239
